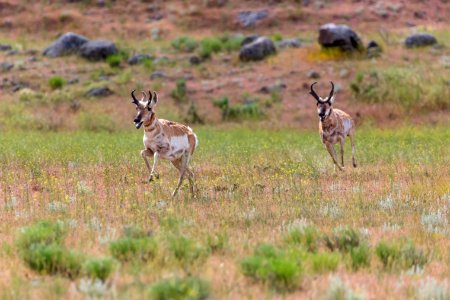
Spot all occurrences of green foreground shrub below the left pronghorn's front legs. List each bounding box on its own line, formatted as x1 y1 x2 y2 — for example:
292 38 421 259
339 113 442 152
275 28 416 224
109 236 158 262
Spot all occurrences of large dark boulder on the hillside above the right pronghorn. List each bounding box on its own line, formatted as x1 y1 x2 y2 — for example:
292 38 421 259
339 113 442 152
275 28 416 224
319 23 364 51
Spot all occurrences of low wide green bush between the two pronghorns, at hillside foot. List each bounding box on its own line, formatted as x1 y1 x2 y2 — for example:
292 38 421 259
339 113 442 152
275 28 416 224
213 97 264 121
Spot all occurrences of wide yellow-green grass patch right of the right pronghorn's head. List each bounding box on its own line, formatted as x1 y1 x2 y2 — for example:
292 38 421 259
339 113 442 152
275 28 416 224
350 67 450 109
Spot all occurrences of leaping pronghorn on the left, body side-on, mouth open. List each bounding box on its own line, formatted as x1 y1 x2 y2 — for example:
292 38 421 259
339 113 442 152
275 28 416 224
131 91 198 197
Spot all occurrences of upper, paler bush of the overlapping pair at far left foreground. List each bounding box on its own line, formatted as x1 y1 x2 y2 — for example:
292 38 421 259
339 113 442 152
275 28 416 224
16 221 67 251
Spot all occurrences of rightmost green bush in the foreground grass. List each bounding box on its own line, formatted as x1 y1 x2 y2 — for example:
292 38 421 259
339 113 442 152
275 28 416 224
375 241 428 270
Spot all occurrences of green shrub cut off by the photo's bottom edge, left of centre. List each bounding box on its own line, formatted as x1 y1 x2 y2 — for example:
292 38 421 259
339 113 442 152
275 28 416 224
148 277 211 300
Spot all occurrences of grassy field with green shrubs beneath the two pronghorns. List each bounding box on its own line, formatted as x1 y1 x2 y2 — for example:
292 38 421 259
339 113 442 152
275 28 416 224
0 124 450 299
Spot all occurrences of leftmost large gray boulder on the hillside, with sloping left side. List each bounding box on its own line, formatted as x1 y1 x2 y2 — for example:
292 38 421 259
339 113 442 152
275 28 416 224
43 32 89 57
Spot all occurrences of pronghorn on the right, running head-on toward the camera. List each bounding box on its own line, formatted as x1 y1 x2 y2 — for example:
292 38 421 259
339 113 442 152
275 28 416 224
309 81 356 171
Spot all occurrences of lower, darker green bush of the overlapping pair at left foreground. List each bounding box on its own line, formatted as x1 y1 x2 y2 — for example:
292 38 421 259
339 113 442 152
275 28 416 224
21 243 84 279
